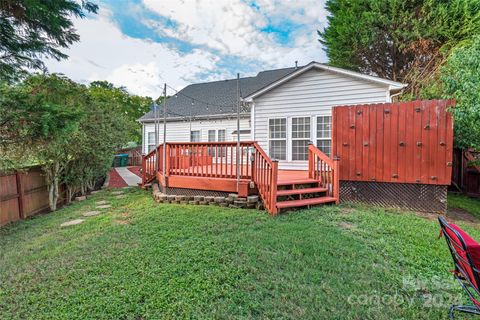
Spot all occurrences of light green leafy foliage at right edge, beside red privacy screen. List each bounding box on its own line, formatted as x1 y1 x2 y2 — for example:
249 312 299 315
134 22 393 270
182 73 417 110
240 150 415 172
436 36 480 150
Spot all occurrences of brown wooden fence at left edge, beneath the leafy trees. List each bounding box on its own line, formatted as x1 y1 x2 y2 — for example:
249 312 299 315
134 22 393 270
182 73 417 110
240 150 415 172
0 167 64 226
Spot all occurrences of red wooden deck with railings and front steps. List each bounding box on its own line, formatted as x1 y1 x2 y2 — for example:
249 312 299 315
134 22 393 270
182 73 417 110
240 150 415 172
143 142 339 214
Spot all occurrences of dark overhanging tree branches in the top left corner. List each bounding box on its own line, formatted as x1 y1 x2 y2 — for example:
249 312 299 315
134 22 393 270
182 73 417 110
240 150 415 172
0 0 98 81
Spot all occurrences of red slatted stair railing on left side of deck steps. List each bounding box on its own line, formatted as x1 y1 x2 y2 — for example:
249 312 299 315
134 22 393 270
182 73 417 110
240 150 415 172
252 142 278 215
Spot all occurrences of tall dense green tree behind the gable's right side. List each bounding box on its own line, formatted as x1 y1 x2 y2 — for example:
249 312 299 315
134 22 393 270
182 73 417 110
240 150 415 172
318 0 480 93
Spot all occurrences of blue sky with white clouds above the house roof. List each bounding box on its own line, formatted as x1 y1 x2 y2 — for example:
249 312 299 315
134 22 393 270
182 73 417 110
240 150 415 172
47 0 327 98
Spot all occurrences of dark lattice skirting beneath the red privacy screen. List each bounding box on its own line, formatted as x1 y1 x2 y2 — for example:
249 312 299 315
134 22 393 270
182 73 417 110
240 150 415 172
340 181 447 213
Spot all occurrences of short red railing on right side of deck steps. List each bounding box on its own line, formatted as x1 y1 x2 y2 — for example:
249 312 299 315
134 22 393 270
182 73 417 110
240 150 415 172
308 144 340 203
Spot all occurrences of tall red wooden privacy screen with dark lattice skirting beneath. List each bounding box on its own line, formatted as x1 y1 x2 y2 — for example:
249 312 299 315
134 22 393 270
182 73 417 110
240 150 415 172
333 100 454 212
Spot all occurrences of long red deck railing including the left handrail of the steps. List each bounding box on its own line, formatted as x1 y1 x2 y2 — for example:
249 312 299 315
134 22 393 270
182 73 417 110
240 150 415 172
142 141 278 214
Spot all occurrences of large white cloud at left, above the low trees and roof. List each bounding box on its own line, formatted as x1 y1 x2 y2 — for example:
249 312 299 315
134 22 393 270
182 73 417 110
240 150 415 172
47 8 219 97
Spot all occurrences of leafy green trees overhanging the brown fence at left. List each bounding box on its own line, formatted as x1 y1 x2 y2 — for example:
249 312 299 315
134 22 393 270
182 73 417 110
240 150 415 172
0 75 146 210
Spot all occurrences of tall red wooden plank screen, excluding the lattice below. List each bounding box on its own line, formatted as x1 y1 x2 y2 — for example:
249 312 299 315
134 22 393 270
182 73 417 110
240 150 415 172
333 100 454 185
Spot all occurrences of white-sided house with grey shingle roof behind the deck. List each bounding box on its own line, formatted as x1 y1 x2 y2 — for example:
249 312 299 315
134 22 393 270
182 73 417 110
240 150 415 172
139 62 406 170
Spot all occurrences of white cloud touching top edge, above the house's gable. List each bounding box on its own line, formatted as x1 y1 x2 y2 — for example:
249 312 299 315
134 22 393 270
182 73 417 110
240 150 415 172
143 0 326 67
